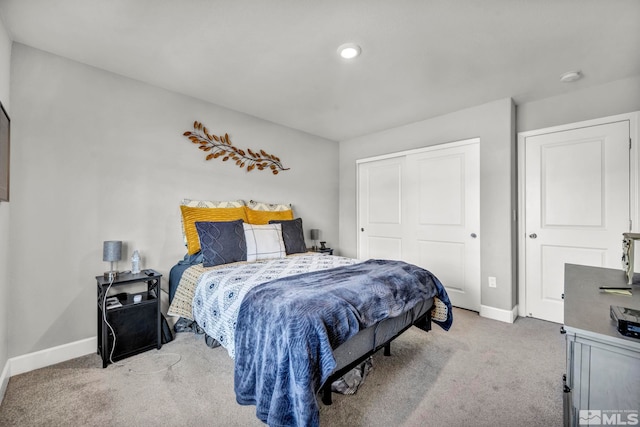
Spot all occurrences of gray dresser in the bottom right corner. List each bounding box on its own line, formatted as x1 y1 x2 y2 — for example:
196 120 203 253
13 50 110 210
564 264 640 426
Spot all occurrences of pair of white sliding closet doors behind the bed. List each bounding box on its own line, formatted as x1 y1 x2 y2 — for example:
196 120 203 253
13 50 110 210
358 139 480 311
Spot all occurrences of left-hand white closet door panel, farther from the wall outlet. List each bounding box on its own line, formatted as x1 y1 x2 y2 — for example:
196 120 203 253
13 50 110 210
358 157 405 260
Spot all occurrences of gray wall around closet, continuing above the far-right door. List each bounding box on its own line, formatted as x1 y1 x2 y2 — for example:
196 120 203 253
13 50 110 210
339 76 640 316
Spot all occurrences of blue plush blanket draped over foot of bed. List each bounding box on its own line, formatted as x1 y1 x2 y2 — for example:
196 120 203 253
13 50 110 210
235 260 453 426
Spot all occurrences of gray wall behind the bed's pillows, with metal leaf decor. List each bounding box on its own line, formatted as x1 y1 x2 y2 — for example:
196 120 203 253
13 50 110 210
7 43 338 356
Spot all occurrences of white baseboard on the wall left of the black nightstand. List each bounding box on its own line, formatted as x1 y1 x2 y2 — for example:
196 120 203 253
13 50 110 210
8 337 98 376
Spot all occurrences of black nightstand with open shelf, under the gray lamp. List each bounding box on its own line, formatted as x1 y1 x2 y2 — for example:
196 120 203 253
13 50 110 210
96 270 162 368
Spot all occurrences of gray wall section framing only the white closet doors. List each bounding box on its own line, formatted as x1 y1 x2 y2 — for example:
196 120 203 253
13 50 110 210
339 99 516 310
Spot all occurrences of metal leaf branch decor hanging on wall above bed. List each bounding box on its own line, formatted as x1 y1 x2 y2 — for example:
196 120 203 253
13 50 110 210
184 121 289 175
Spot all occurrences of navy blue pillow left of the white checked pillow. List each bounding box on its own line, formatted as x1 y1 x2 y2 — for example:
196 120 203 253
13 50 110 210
195 219 247 267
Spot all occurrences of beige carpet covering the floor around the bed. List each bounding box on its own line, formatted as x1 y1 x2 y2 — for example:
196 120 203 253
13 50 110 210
0 309 565 427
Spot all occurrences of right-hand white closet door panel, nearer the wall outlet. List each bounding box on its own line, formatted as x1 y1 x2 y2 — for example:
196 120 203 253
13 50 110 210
406 140 480 311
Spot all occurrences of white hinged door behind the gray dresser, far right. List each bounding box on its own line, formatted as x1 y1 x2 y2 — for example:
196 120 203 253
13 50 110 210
524 122 630 323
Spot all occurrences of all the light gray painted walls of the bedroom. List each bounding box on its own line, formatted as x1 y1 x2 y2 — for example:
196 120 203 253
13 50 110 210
0 38 640 362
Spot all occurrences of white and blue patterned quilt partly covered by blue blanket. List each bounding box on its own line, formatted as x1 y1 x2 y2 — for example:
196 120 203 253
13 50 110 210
193 254 360 358
